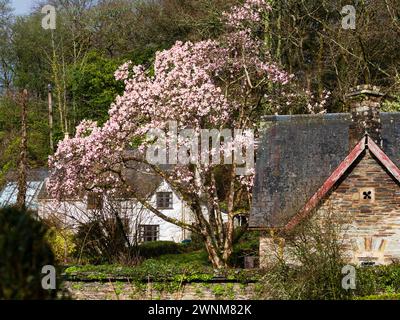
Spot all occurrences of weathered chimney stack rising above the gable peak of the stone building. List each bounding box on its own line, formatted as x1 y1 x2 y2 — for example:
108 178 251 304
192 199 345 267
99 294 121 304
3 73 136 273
346 85 384 149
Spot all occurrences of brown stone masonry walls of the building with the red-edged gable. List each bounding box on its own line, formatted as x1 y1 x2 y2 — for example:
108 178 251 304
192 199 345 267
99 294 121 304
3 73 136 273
260 150 400 267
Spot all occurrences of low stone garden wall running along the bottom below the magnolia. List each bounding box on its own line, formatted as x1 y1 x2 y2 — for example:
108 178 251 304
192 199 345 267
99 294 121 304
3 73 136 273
64 281 261 300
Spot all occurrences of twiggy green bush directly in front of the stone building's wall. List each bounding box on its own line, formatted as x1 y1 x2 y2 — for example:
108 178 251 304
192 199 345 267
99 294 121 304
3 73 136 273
265 218 354 300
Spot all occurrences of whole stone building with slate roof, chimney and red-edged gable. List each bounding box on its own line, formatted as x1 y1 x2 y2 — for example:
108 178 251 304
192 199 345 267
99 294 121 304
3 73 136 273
249 86 400 266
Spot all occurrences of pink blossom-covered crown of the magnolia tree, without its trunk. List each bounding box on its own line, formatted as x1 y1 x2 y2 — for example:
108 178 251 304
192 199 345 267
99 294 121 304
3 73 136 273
48 0 290 205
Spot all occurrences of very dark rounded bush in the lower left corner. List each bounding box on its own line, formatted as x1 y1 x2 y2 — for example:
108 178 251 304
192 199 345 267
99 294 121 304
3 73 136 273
0 208 58 300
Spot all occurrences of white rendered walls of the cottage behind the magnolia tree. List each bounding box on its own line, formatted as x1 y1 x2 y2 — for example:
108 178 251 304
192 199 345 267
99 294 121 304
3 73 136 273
38 181 192 242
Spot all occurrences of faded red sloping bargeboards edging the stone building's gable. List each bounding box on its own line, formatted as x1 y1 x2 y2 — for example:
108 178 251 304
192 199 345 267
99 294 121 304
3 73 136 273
284 135 400 232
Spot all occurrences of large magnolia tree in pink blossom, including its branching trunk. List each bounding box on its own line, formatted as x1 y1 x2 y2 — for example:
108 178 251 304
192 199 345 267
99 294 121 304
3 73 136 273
48 0 290 268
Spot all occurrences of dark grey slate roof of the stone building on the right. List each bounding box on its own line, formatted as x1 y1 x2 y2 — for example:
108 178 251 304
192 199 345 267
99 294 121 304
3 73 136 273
249 113 400 228
